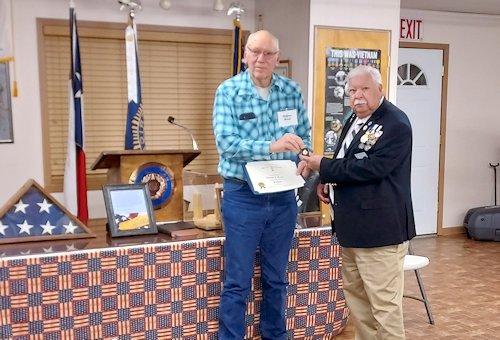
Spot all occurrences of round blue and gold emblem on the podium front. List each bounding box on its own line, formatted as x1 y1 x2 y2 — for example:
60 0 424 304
129 162 175 210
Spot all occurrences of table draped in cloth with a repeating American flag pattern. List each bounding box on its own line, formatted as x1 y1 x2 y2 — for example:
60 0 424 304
0 227 349 340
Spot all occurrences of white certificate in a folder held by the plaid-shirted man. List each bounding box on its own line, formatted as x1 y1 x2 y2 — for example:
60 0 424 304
243 160 305 194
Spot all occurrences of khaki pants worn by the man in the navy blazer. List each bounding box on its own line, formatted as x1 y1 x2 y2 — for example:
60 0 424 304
342 242 408 340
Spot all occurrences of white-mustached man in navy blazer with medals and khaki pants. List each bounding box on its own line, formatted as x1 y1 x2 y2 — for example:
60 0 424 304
297 66 415 340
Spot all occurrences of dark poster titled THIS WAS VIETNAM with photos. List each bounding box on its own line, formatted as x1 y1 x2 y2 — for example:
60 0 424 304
323 47 382 155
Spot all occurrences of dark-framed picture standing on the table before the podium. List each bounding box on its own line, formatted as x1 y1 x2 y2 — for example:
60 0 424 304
103 183 158 237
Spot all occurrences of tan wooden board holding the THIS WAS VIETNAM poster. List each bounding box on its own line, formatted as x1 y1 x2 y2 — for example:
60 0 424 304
312 26 391 224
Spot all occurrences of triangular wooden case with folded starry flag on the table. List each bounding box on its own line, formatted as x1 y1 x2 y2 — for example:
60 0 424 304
0 179 95 244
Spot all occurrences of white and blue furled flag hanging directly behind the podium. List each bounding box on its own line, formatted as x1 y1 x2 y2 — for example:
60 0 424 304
125 17 146 150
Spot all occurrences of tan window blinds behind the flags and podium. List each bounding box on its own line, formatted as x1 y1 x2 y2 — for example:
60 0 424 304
41 23 232 191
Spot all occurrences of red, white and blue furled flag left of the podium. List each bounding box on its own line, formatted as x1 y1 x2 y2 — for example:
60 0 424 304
64 1 89 224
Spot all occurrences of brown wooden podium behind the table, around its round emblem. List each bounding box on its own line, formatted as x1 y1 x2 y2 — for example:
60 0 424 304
91 150 200 223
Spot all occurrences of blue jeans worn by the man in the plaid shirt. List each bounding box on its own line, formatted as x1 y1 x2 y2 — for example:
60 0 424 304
219 180 297 340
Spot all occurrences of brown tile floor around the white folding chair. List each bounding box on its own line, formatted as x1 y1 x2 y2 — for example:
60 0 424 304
333 234 500 340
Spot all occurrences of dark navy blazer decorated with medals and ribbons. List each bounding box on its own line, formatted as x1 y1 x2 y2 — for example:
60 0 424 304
320 99 415 248
